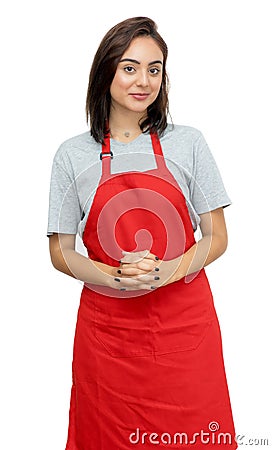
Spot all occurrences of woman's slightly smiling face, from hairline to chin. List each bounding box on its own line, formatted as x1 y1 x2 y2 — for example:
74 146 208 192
110 36 163 113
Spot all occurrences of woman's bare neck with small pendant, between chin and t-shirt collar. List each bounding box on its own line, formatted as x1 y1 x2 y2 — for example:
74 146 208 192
109 104 147 142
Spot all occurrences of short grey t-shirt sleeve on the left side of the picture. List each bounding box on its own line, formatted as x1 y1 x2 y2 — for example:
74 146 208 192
47 153 82 236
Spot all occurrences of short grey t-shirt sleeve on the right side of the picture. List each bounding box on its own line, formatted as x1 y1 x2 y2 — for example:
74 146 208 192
189 133 231 214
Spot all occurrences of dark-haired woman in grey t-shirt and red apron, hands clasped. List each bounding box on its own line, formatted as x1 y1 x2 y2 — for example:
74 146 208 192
48 17 237 450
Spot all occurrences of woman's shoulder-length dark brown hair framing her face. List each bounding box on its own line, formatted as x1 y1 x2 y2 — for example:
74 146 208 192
86 17 168 143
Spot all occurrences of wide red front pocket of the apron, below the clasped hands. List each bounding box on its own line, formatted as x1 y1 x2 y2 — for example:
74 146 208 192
93 274 215 357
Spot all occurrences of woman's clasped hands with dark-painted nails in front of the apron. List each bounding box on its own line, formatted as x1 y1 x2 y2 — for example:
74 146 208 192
112 250 181 291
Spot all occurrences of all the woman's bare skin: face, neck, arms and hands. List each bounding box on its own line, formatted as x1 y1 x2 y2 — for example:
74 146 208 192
49 37 230 290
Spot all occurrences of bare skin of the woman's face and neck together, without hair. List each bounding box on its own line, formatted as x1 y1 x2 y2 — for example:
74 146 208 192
109 37 163 142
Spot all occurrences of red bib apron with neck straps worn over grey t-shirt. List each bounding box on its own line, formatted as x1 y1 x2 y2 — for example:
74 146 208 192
66 135 237 450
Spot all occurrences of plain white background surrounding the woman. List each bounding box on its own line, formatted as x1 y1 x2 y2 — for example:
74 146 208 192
0 0 272 450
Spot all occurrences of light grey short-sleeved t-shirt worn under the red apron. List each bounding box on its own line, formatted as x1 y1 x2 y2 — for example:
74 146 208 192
47 125 231 236
